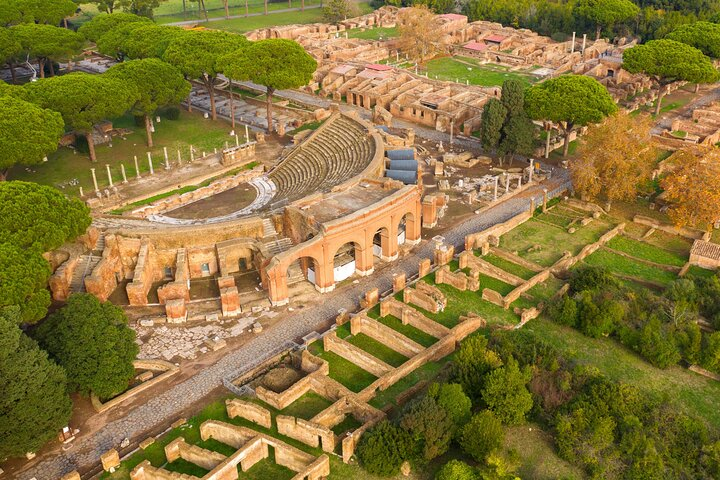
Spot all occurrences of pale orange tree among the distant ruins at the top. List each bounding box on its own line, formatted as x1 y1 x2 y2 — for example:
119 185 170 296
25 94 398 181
397 5 444 62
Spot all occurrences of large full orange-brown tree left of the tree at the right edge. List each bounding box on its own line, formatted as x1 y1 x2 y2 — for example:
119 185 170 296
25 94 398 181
569 113 657 208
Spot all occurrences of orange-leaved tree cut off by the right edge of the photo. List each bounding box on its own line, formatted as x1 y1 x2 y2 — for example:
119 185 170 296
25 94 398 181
660 146 720 231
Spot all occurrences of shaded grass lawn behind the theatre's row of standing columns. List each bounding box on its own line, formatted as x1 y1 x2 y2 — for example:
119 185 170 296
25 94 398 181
10 111 236 196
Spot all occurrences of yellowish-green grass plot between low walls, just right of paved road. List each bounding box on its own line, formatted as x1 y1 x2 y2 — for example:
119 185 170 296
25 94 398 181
500 218 613 267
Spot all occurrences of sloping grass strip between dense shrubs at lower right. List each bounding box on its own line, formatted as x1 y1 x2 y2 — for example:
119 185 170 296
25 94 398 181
523 317 720 431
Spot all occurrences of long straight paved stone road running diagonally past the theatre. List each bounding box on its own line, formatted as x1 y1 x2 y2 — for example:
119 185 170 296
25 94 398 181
18 170 569 480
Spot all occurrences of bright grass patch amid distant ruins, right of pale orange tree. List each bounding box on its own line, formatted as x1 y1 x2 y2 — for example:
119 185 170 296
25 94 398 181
425 57 537 87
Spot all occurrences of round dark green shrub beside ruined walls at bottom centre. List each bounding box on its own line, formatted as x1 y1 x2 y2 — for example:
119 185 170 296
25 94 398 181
357 420 413 477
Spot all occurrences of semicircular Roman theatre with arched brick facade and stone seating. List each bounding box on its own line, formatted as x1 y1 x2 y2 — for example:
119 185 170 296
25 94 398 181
50 112 422 316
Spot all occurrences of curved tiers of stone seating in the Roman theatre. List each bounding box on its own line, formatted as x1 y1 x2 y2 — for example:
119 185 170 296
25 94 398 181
269 116 375 200
